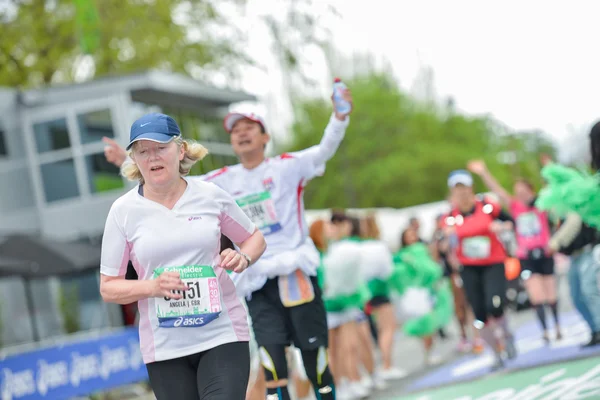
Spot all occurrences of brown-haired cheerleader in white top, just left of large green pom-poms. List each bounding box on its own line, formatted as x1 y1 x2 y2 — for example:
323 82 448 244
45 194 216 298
361 215 407 381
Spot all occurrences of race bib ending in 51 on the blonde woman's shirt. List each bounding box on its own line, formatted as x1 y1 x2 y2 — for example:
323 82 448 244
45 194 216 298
154 265 221 328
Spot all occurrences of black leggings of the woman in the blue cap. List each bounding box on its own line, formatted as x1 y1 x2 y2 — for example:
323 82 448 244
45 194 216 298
146 342 250 400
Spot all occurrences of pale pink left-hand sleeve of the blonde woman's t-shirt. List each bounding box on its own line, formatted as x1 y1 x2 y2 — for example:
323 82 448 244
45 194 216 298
100 205 129 276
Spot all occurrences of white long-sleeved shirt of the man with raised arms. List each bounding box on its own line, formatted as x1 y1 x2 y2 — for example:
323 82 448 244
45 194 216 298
189 115 350 296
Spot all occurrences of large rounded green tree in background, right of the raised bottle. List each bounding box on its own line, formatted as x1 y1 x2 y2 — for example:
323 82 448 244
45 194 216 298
282 74 554 208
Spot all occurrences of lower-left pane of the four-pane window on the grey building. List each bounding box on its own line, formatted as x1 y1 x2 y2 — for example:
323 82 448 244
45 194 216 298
40 158 79 203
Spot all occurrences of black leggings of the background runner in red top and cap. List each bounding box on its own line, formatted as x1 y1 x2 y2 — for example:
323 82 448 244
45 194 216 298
460 264 507 322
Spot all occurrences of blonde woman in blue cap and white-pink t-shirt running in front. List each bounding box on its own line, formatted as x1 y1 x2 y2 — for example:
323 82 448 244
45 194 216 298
100 114 266 400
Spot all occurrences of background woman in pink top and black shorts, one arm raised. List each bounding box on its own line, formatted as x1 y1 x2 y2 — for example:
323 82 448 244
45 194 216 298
468 160 562 343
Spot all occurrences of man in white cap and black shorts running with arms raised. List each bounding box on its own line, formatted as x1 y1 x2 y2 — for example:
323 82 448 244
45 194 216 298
104 91 352 400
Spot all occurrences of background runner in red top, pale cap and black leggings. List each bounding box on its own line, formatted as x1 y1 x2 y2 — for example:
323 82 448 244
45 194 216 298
444 170 516 369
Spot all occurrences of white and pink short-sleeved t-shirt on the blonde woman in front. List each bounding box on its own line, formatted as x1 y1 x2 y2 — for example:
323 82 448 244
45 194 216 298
100 179 255 363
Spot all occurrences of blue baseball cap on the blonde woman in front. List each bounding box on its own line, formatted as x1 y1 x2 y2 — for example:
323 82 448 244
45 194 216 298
127 113 181 150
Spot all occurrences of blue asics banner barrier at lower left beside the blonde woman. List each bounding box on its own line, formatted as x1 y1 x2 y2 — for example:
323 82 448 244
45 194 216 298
0 328 148 400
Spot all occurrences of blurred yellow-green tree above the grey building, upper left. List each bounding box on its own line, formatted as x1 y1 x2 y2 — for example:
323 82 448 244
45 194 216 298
0 0 330 87
